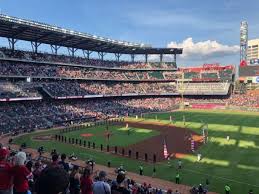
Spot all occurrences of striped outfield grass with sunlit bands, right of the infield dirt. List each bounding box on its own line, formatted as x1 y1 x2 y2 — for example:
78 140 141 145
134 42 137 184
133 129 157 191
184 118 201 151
145 110 259 193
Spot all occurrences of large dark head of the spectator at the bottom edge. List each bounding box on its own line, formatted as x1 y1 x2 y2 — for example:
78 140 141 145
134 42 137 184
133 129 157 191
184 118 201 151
36 166 69 194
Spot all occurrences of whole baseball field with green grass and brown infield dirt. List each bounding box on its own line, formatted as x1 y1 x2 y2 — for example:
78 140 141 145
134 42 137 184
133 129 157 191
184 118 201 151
12 110 259 194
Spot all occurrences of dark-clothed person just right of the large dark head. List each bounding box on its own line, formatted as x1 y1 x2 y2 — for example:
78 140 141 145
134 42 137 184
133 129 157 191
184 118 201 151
69 165 80 194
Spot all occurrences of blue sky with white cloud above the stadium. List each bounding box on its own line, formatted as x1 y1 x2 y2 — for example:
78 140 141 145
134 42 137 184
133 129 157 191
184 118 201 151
0 0 259 66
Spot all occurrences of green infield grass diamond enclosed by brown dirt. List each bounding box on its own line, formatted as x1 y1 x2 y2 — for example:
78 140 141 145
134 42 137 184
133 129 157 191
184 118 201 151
63 125 159 147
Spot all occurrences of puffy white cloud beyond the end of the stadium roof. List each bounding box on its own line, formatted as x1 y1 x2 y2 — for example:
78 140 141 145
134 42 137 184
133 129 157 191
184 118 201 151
167 37 239 60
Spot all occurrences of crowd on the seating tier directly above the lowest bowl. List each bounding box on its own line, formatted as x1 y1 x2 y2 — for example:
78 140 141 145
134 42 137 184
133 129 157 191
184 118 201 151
0 80 234 99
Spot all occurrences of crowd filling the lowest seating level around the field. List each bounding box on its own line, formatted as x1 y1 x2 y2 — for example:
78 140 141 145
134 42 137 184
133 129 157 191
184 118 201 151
0 91 259 132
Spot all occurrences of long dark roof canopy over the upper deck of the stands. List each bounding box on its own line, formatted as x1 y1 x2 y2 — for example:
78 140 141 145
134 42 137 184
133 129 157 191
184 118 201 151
0 14 182 55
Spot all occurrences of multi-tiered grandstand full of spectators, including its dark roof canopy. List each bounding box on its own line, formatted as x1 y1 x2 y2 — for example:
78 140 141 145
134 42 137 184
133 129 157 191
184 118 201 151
0 15 238 132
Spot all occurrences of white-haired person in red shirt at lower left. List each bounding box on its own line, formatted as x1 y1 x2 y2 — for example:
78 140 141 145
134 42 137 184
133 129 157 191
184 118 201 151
11 152 32 194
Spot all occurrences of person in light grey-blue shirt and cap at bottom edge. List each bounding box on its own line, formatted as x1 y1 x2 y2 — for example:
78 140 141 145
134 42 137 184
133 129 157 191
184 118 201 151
93 171 111 194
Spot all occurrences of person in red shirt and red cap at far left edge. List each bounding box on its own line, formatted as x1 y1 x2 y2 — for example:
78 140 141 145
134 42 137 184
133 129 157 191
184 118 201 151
0 148 12 194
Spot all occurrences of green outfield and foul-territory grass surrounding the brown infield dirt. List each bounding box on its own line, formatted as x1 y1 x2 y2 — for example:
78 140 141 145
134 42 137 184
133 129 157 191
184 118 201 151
15 110 259 194
